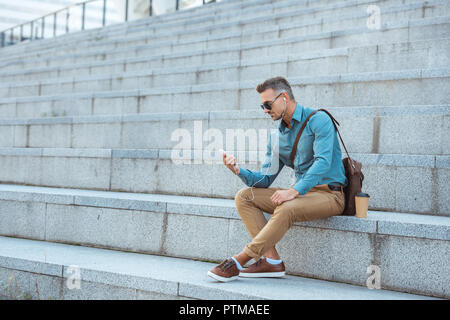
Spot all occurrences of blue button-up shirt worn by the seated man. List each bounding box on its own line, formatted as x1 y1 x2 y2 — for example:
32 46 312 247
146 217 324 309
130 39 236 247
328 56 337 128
238 103 347 195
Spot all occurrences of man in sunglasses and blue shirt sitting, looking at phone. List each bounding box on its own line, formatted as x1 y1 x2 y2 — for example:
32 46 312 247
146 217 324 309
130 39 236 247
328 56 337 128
208 77 347 282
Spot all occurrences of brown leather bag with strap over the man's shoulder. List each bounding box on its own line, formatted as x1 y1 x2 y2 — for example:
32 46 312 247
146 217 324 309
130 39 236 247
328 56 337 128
291 109 364 216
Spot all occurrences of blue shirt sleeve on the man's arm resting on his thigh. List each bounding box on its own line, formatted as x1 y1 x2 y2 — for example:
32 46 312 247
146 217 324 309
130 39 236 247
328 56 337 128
293 112 336 195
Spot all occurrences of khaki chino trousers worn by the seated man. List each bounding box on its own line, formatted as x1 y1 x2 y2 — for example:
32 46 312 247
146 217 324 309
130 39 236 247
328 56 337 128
235 184 345 260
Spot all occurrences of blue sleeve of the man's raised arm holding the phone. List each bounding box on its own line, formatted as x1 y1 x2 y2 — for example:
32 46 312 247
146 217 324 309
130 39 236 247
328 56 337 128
238 134 284 188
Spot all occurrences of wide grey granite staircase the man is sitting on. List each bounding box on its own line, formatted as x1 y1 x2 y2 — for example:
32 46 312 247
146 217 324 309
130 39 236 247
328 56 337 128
0 0 450 299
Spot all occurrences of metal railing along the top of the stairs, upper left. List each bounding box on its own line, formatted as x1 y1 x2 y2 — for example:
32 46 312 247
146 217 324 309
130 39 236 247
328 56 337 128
0 0 220 48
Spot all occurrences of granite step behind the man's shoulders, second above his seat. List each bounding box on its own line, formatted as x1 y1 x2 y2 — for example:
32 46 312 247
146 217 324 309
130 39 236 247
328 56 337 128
0 105 450 155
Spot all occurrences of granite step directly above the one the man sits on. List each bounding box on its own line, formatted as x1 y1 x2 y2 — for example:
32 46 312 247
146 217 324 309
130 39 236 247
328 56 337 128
0 148 450 216
